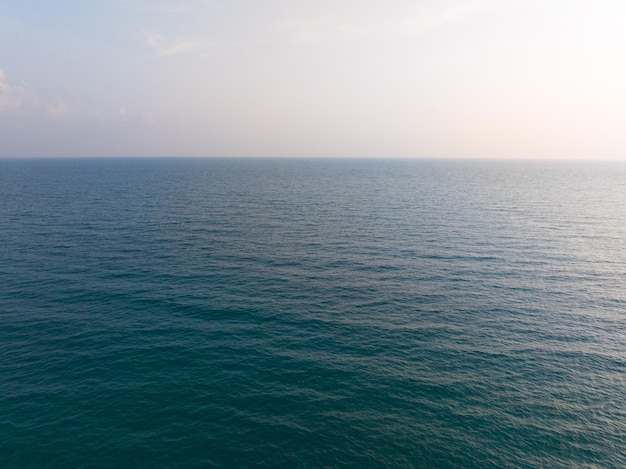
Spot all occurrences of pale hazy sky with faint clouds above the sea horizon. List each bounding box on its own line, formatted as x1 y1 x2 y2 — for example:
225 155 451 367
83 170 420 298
0 0 626 159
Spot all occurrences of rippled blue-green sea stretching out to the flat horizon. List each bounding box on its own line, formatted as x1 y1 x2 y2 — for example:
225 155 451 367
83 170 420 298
0 159 626 468
